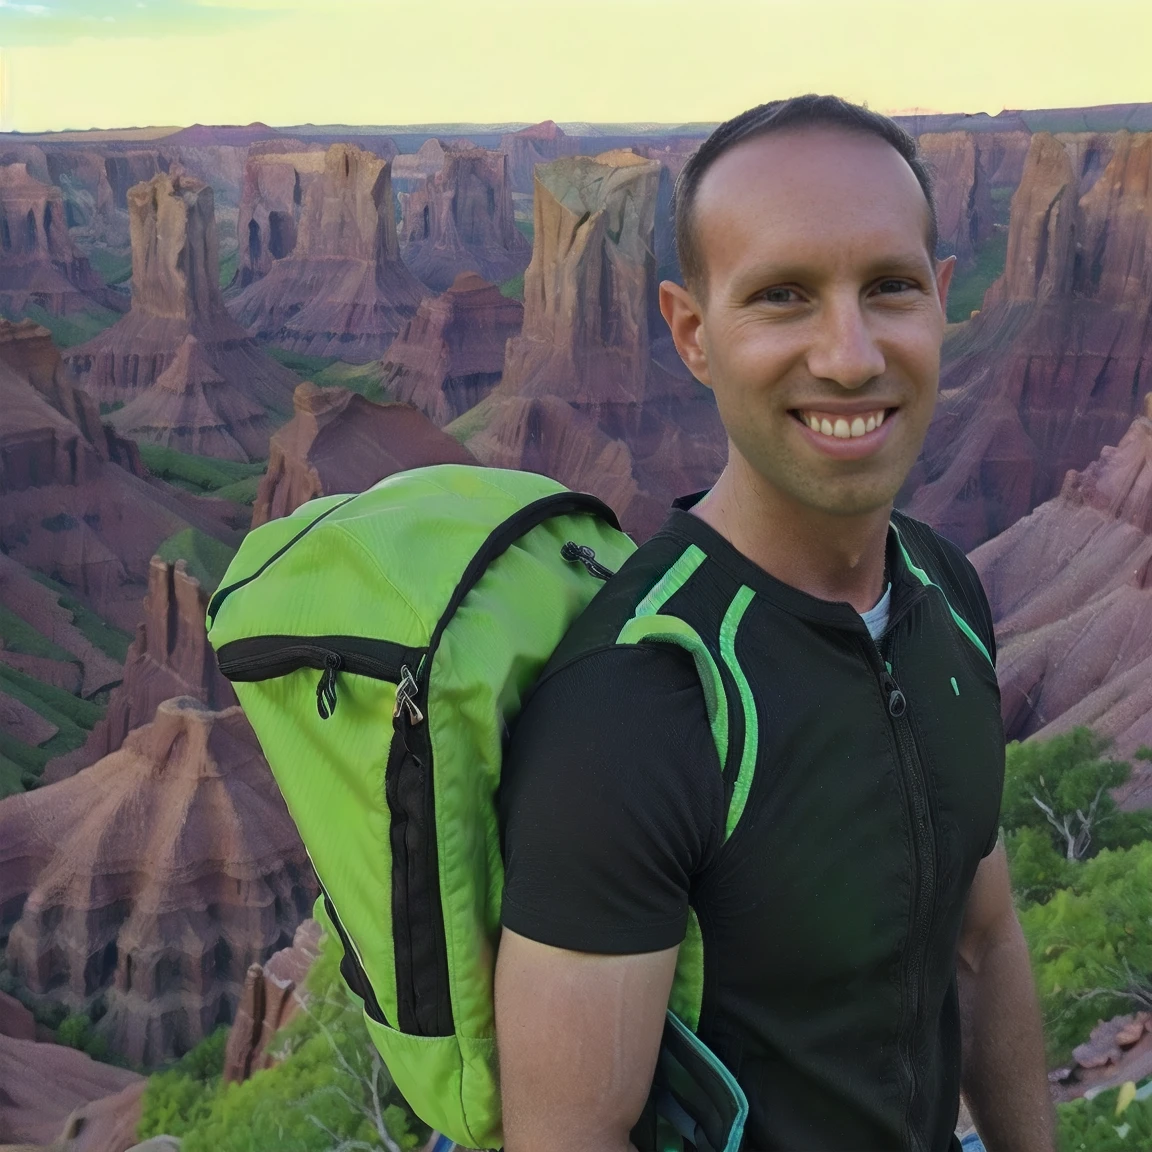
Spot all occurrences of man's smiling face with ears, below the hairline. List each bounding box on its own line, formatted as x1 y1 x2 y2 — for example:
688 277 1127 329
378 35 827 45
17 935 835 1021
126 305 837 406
661 127 954 515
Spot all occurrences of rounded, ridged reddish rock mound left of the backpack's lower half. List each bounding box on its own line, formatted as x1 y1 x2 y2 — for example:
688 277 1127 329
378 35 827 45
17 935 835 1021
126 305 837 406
0 697 316 1066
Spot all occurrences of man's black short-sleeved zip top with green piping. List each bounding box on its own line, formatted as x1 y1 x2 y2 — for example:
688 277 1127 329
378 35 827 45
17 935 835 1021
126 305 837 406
500 510 1003 1152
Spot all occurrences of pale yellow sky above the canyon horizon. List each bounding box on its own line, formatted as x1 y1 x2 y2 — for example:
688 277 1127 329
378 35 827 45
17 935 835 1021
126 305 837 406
0 0 1152 131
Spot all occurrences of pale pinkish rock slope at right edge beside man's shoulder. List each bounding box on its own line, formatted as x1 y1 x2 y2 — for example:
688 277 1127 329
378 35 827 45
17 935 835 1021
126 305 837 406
971 395 1152 806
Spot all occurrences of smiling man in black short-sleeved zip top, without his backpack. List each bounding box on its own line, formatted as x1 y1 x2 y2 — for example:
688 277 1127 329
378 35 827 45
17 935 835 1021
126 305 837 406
497 96 1053 1152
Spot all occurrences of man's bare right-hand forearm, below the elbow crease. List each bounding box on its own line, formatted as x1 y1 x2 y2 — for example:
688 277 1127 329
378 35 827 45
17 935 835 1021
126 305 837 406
957 916 1055 1152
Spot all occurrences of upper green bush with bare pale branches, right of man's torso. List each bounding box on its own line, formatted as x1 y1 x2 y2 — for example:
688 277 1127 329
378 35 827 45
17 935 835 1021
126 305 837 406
1001 728 1152 862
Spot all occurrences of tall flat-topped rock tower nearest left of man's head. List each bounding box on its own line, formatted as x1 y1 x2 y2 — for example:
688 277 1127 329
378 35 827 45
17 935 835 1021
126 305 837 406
453 152 726 536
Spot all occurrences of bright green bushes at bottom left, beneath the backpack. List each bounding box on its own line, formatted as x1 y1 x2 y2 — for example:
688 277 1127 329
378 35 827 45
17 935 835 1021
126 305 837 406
136 935 429 1152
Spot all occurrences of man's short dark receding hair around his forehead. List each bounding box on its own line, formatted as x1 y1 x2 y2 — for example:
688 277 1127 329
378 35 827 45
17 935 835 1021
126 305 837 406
672 92 940 290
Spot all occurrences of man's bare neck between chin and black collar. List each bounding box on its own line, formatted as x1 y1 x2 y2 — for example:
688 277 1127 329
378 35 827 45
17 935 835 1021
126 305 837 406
691 454 892 612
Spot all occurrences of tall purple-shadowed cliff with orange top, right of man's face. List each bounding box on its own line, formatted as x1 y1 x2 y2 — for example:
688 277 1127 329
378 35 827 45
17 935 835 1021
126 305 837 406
903 132 1152 548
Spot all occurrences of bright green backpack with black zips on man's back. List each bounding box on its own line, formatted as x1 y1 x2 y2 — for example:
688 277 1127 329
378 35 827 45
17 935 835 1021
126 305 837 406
207 464 746 1152
